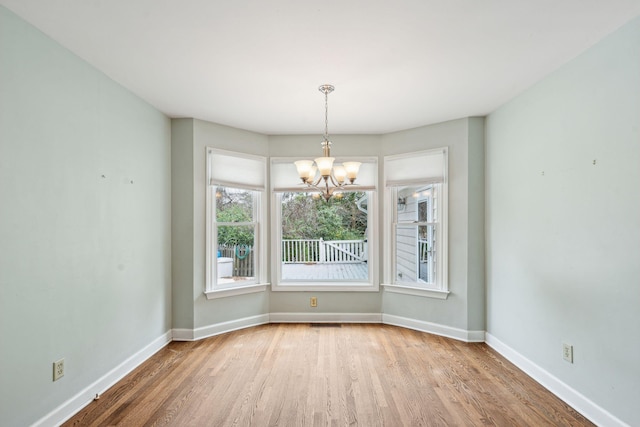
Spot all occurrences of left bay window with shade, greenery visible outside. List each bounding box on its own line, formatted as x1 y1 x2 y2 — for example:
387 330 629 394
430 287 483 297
205 148 266 298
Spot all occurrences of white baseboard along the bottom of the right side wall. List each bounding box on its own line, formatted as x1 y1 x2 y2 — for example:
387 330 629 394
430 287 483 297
485 333 629 427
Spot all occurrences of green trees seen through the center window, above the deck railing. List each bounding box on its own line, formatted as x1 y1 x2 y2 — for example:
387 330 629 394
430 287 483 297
282 192 367 240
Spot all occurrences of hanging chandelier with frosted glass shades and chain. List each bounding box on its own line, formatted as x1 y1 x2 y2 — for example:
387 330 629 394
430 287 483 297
294 85 361 201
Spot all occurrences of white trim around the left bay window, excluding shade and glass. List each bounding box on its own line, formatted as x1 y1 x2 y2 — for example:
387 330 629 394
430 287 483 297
204 147 269 299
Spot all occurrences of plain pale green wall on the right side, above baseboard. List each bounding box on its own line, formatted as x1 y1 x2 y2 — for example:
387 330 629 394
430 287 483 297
486 15 640 425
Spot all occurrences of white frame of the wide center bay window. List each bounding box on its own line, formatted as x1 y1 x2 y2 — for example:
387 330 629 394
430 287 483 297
271 157 380 292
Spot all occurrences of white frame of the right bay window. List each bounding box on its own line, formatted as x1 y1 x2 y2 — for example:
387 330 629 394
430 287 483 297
383 147 449 299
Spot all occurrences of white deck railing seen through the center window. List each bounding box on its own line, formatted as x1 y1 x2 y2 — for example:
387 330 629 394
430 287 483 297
282 239 367 264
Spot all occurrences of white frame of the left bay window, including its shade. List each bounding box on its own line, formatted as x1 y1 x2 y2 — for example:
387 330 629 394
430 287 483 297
204 147 269 299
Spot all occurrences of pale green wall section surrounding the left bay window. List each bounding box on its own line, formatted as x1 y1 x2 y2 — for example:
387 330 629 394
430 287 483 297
171 119 269 330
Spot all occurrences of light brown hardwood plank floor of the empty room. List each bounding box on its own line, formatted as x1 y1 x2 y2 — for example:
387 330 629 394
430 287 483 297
64 324 592 427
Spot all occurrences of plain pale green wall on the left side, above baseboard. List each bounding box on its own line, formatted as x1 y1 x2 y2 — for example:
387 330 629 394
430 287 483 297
0 6 171 427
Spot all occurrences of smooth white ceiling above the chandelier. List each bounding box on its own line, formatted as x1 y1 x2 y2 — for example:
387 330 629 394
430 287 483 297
0 0 640 135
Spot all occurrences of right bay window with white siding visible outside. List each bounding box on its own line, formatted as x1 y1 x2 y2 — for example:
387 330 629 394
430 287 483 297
385 148 448 298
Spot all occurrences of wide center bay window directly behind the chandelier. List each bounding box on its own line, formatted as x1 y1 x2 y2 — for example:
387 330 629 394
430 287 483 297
271 158 378 291
